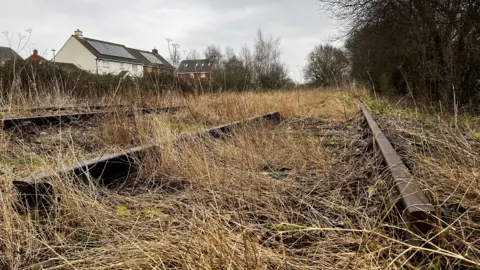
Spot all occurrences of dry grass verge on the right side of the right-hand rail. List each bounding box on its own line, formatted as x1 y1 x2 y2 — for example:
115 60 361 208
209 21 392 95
381 106 480 268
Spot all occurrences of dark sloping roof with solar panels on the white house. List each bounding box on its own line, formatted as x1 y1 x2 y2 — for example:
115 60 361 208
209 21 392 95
72 35 143 64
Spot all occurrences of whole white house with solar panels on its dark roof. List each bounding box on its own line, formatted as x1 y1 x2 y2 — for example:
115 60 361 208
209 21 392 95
55 29 173 77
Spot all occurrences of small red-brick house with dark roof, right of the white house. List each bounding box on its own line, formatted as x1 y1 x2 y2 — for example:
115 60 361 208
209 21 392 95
177 59 215 80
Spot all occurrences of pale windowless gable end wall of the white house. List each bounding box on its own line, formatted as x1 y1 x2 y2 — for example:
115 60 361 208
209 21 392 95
55 37 97 73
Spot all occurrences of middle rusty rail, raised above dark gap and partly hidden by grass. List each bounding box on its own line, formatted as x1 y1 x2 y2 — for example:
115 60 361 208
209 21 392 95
13 112 282 201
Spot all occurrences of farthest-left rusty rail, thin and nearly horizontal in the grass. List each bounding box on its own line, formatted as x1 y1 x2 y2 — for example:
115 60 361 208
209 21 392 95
1 106 183 130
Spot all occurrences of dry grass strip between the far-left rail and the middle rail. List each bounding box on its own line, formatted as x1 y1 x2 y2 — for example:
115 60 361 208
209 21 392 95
0 108 189 177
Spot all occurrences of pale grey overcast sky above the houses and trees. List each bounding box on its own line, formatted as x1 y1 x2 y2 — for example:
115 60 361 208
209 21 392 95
0 0 338 81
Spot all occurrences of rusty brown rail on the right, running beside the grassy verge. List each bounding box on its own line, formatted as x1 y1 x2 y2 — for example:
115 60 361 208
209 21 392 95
361 106 435 233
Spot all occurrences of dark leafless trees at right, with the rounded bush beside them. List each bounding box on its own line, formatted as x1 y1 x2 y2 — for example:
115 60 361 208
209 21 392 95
312 0 480 109
